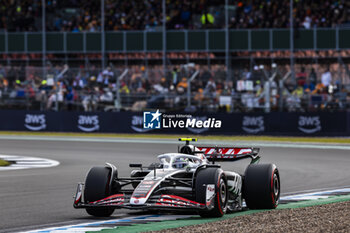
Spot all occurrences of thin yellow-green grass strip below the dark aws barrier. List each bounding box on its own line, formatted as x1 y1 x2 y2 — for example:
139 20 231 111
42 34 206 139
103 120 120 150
0 131 350 144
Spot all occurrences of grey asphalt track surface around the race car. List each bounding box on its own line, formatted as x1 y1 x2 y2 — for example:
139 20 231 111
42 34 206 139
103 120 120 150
0 139 350 232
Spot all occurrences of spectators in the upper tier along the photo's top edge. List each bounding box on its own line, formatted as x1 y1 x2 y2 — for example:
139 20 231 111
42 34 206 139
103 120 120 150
0 0 350 32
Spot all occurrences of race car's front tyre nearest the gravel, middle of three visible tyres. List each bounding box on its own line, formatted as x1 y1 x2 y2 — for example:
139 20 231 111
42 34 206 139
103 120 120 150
195 167 228 217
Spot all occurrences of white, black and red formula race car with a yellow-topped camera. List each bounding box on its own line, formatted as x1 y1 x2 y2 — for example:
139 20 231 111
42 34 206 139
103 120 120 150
74 138 280 217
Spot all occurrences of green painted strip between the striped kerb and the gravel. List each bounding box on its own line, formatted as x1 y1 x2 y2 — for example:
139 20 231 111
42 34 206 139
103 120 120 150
89 195 350 233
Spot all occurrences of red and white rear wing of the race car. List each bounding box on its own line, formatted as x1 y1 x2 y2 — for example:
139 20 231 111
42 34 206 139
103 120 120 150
194 146 260 163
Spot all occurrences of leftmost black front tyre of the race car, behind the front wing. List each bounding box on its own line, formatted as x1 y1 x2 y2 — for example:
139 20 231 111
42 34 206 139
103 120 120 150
84 167 114 217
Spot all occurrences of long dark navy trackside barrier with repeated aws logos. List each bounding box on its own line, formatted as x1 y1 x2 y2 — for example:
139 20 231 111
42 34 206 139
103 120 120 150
0 110 350 136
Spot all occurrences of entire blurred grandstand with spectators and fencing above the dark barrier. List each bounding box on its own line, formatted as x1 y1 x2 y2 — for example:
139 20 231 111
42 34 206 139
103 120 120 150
0 0 350 113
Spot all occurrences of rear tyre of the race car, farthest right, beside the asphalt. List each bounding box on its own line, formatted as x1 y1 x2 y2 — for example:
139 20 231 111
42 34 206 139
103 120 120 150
243 164 280 209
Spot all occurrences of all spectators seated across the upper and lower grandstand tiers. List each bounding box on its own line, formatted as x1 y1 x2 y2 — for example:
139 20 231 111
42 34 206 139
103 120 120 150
0 0 350 111
